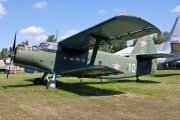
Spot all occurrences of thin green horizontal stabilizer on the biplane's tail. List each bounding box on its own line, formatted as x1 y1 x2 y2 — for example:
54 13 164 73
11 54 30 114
137 53 175 59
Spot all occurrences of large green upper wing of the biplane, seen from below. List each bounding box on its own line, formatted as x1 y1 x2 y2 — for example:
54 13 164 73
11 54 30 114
58 14 159 50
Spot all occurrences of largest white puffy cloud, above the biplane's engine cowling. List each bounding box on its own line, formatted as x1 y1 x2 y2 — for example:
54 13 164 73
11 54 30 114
20 26 47 41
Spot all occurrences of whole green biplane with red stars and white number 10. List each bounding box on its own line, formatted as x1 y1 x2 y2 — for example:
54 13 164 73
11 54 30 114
7 14 173 89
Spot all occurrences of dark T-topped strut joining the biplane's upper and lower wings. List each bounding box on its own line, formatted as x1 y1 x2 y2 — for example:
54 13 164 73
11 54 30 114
89 34 109 65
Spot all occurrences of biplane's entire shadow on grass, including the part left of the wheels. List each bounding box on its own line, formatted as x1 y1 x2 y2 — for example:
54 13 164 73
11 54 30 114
2 79 160 96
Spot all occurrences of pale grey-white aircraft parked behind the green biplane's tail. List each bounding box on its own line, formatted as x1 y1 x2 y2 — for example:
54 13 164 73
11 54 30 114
114 15 180 64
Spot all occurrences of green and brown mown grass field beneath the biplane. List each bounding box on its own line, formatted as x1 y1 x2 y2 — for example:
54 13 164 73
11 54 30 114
0 70 180 120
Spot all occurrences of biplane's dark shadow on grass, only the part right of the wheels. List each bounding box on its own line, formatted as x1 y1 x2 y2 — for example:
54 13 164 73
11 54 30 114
54 80 159 96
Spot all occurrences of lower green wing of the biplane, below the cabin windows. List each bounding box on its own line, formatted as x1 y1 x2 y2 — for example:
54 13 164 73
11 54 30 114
60 65 123 77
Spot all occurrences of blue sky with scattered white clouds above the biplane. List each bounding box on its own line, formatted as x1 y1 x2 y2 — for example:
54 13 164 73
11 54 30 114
0 0 180 50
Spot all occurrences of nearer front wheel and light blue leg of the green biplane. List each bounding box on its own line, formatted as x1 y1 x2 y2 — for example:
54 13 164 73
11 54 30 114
46 73 57 89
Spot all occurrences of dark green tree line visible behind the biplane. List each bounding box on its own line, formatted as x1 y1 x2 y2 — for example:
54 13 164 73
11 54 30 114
0 31 169 59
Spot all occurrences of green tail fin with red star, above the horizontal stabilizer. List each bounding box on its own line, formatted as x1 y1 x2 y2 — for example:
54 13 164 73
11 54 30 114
131 36 156 56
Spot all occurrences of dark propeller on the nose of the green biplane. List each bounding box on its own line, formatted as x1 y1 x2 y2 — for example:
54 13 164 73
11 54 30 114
6 31 17 78
